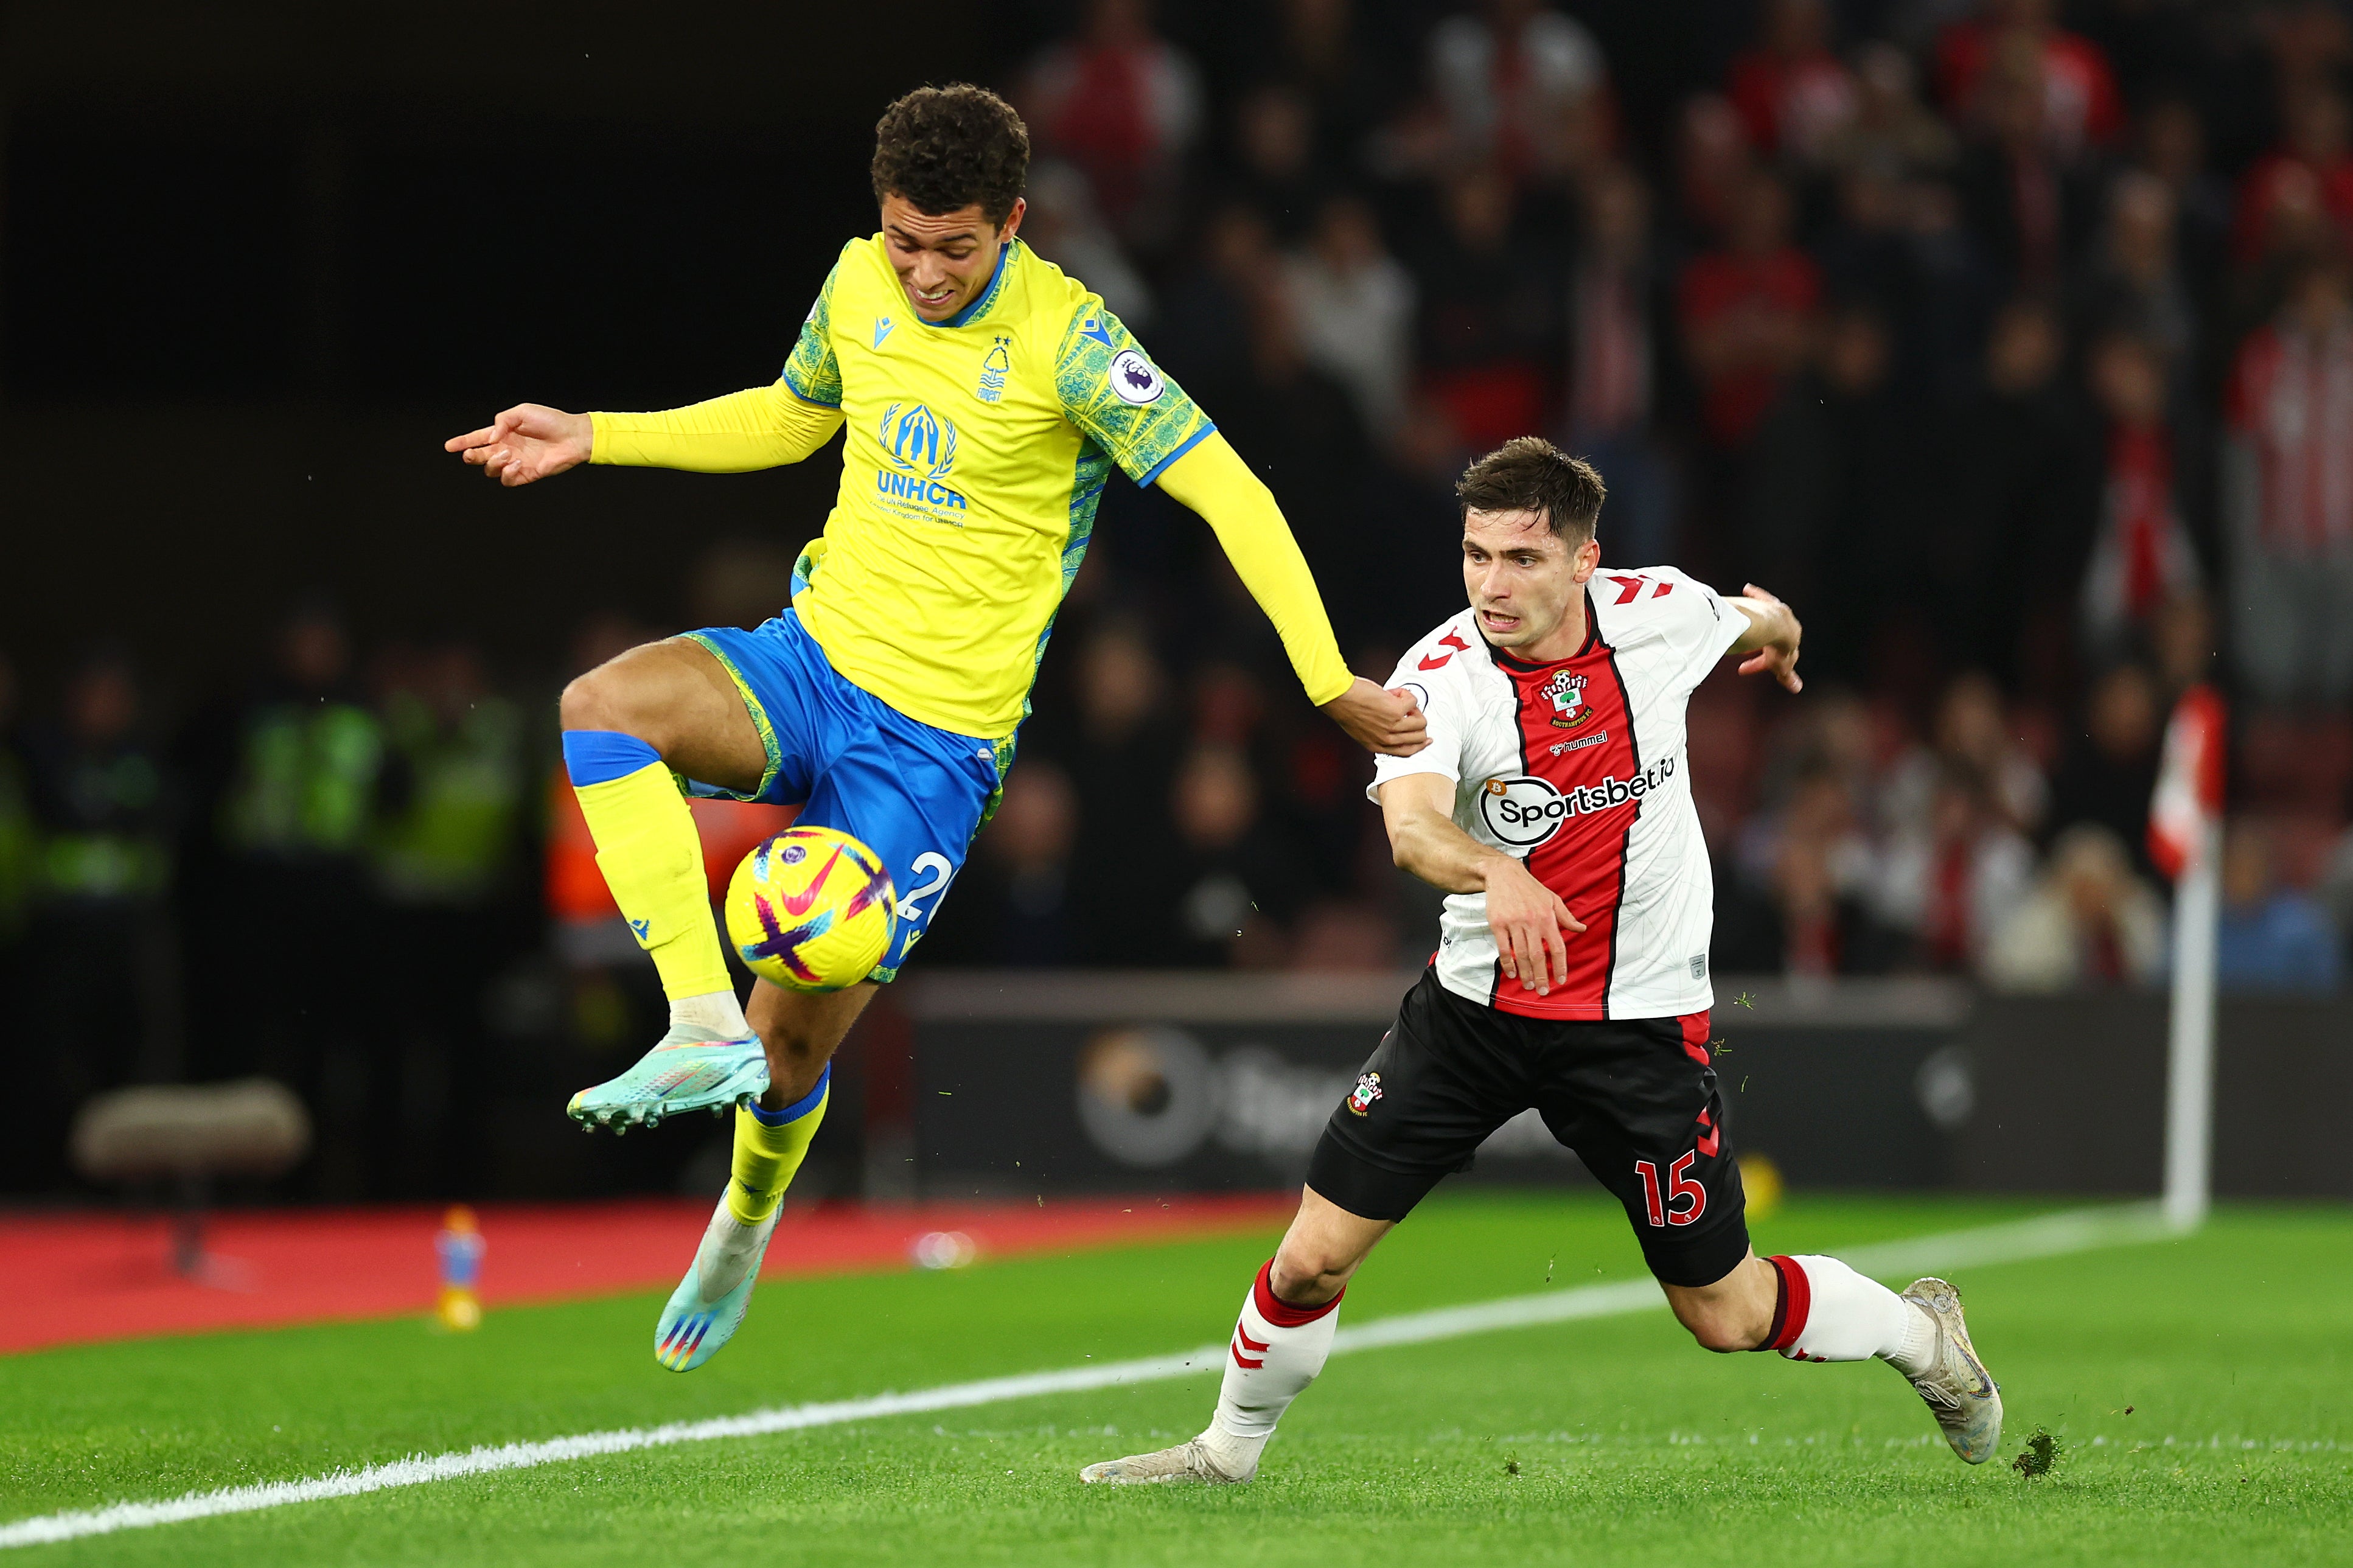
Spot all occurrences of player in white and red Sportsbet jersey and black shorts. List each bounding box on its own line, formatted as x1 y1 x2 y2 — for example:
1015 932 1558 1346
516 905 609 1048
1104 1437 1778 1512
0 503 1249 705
1080 436 2003 1481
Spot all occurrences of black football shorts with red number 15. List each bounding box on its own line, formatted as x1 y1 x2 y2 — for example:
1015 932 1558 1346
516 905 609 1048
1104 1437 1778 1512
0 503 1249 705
1308 970 1748 1286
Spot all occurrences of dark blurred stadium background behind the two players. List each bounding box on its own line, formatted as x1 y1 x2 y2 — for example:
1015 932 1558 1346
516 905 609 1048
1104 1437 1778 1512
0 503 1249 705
0 0 2353 1200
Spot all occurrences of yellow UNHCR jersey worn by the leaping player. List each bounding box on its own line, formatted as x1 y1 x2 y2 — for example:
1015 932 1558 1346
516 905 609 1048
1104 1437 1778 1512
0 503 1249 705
595 235 1348 737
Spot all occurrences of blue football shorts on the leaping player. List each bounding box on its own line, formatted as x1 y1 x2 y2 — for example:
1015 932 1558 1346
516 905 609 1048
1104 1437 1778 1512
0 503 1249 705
687 610 1014 982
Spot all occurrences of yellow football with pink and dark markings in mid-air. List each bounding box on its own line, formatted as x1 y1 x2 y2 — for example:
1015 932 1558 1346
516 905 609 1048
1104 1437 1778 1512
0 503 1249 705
727 826 899 991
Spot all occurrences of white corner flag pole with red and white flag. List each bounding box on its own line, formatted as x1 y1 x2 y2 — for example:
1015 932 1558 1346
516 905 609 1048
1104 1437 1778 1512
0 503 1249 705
2149 685 2223 1232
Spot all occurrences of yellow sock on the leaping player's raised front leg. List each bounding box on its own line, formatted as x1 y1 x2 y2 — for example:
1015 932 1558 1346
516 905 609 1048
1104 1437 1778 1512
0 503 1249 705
572 763 734 1000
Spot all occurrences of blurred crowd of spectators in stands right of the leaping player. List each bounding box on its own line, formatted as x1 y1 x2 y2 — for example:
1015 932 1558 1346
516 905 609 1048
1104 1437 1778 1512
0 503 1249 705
936 0 2353 989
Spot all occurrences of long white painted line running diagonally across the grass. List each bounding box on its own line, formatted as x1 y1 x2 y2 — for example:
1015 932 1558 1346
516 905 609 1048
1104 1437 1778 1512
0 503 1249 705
0 1203 2172 1549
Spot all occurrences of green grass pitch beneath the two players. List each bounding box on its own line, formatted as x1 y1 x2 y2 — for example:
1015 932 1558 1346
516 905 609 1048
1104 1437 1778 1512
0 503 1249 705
0 1191 2353 1568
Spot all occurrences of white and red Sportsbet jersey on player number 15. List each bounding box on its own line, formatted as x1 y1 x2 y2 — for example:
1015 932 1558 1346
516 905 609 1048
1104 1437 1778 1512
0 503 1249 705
1372 568 1748 1019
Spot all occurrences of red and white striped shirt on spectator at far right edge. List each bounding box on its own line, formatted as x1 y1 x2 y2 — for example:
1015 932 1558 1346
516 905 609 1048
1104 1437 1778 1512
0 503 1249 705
2228 327 2353 558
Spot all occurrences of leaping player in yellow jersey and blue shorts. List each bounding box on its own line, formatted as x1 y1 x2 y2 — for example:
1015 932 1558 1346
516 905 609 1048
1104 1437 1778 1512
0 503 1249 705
450 85 1426 1370
